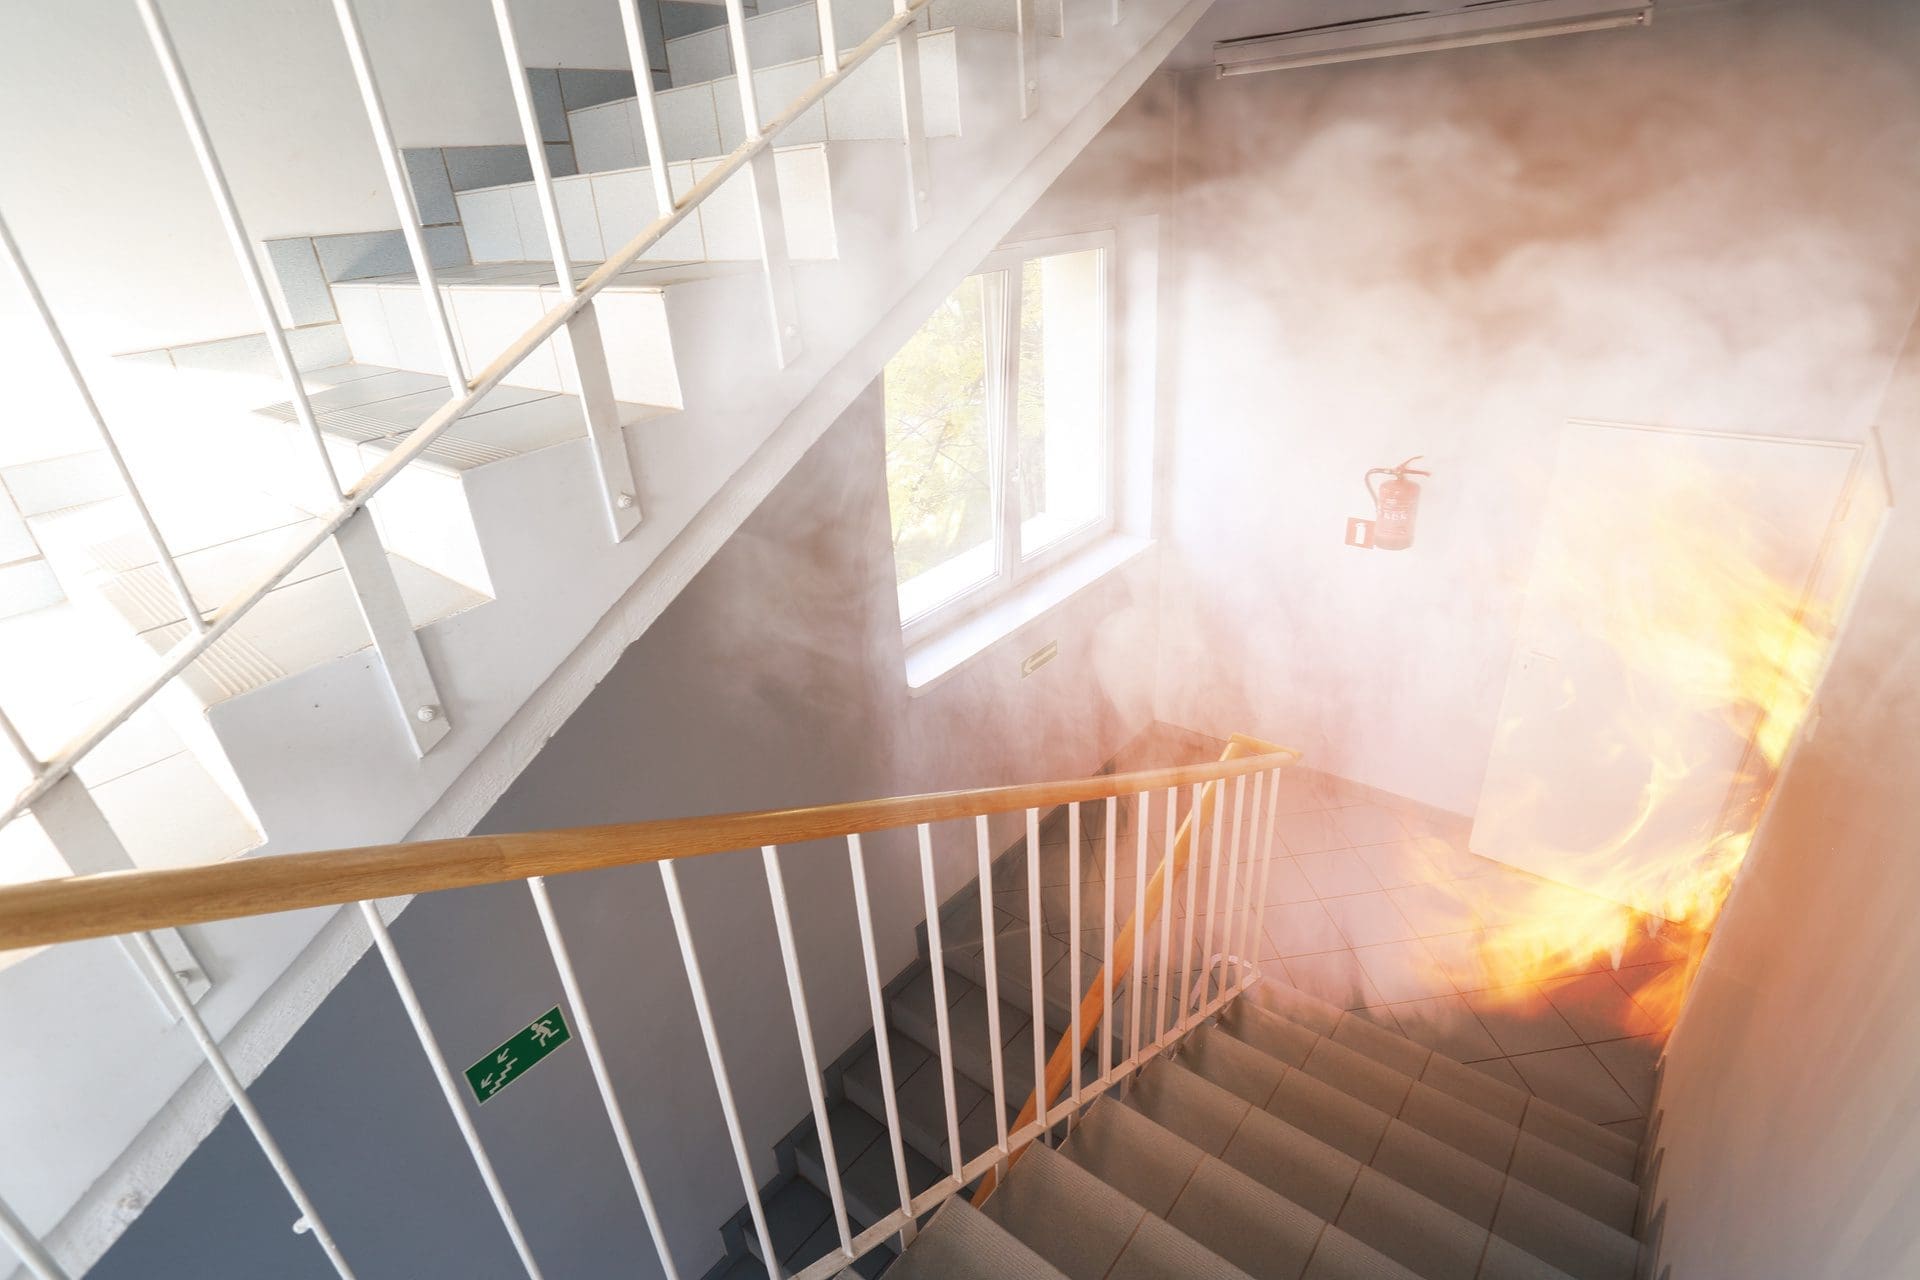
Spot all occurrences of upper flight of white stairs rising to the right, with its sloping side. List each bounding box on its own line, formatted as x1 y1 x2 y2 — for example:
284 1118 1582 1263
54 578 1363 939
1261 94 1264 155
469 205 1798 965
0 0 1206 1249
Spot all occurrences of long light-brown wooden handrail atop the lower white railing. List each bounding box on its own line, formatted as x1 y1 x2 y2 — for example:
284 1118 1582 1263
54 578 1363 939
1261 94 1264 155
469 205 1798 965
0 739 1300 952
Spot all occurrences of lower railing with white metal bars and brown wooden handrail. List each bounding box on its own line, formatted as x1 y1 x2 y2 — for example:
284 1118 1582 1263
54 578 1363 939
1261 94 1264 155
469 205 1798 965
0 739 1298 1280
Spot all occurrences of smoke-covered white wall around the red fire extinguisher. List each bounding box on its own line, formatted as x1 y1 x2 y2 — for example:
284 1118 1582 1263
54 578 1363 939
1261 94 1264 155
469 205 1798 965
1142 0 1920 812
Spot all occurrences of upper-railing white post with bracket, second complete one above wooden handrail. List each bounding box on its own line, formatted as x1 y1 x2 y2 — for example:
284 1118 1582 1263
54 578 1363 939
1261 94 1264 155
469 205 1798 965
493 0 645 541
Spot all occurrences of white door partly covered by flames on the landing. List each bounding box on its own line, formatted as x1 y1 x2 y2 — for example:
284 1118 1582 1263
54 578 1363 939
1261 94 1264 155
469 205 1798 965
1471 422 1860 913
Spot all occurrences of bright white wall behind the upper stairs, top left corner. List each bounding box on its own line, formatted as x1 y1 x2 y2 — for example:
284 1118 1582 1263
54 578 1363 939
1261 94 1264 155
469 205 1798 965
0 0 626 376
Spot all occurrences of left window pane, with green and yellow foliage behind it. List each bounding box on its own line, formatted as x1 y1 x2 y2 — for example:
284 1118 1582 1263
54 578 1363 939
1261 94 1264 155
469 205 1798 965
885 276 995 622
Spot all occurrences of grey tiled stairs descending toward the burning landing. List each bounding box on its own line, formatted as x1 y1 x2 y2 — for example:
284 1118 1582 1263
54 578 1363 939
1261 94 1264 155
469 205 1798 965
712 806 1640 1280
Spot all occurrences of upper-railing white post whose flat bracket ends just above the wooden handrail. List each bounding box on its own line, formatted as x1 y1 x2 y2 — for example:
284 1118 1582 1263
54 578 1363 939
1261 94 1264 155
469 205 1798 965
132 0 449 754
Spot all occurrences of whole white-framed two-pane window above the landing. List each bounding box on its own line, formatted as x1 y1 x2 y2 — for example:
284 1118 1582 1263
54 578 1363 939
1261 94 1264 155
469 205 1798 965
885 236 1114 641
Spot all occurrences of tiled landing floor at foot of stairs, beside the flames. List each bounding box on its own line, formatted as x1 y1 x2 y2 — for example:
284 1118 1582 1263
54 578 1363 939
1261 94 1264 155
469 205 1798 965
973 736 1686 1136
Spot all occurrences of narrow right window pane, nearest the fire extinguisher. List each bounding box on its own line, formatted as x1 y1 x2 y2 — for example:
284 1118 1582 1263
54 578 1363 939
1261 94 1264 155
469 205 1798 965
1018 249 1108 557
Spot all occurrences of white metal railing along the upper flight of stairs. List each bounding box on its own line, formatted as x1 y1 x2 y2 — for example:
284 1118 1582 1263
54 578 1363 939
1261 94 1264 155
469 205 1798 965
0 0 960 974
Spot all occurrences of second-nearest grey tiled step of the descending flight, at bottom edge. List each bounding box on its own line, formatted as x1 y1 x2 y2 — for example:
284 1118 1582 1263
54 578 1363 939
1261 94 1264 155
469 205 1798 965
981 1144 1248 1280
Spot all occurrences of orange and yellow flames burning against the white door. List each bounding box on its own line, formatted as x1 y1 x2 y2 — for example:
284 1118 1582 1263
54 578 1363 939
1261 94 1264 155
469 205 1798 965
1478 443 1868 1027
